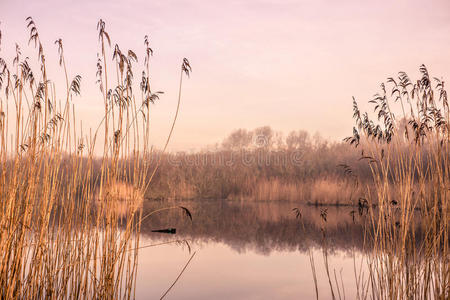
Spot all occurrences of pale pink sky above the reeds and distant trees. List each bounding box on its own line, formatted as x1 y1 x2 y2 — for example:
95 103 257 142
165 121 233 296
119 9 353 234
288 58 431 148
0 0 450 150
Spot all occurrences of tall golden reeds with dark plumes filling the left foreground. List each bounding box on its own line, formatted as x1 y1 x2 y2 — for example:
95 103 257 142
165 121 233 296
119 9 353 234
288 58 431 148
0 18 190 299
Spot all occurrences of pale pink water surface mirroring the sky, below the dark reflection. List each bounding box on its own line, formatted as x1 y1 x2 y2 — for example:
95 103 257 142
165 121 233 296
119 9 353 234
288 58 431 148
136 238 360 300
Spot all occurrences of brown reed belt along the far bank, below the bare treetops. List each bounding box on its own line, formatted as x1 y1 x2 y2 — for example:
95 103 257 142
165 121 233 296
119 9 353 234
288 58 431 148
142 143 371 205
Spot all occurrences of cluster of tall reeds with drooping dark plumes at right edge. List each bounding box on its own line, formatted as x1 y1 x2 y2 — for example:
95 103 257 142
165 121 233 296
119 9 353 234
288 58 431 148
347 65 450 299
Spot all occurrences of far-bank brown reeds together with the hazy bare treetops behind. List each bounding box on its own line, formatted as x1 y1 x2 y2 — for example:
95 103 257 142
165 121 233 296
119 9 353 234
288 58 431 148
138 130 436 206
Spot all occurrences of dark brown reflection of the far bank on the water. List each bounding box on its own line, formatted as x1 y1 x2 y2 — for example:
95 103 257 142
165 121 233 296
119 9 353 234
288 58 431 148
134 201 370 254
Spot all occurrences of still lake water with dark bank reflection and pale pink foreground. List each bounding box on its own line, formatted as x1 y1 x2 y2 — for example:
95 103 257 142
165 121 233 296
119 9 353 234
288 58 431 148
136 200 367 299
